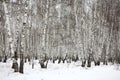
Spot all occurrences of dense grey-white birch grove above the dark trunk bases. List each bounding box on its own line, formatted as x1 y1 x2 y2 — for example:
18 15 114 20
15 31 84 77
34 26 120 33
0 0 120 64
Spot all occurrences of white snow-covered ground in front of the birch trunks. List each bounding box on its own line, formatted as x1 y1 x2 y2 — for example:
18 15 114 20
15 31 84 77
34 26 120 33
0 60 120 80
